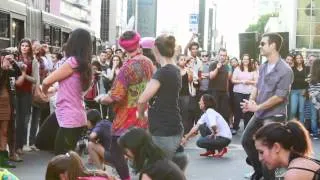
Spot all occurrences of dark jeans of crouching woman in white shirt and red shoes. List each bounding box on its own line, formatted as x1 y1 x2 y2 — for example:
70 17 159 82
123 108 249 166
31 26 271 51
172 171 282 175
197 124 231 151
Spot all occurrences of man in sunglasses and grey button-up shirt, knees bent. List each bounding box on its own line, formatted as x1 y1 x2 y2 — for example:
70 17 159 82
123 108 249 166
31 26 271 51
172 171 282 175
241 33 293 180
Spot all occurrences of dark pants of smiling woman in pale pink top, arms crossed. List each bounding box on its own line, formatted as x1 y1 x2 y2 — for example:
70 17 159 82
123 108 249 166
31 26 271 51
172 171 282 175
233 92 253 130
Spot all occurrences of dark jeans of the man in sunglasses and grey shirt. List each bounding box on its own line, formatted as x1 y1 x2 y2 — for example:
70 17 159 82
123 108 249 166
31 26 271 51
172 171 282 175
241 115 286 180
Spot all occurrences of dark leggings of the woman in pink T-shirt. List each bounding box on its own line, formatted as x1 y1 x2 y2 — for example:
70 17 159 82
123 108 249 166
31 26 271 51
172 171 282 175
54 127 83 155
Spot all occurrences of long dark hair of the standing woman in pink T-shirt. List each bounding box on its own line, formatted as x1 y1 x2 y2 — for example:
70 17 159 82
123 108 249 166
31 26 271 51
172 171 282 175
66 28 92 91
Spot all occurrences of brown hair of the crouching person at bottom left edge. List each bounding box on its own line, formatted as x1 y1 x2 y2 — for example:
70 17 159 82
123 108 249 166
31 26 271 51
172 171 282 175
46 151 108 180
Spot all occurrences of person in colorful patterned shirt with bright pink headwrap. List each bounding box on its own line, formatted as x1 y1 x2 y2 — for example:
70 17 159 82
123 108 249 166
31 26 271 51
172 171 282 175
97 31 153 179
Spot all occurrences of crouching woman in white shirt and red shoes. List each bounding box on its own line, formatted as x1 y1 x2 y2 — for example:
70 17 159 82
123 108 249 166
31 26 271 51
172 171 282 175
181 94 232 157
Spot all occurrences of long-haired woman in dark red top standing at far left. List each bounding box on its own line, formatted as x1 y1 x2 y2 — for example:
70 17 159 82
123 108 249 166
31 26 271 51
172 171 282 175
16 39 40 155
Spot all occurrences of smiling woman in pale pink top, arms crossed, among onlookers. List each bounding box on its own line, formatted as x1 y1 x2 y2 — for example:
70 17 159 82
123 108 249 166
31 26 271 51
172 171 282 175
232 54 258 134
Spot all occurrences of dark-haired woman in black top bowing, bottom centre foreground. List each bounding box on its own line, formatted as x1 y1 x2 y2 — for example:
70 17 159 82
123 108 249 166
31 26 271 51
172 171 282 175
118 128 186 180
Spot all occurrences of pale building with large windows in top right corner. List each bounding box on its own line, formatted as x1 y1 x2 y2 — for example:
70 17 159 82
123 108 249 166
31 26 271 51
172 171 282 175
265 0 320 54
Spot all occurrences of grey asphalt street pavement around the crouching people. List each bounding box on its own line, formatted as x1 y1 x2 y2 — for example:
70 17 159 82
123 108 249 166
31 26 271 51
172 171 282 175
11 131 320 180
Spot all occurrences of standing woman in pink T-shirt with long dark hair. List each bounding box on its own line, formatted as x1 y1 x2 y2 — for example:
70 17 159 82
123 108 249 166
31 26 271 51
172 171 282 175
42 28 92 154
